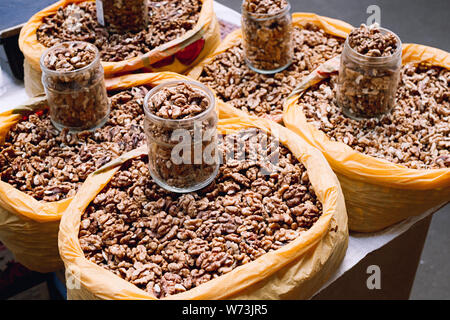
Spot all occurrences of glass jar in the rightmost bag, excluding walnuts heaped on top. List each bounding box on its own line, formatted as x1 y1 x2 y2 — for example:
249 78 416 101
336 28 402 120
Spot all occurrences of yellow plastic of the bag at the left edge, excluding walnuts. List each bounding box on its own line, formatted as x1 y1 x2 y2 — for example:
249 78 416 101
0 72 187 272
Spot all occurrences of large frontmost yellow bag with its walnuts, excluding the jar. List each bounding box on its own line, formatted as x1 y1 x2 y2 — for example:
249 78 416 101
59 117 348 300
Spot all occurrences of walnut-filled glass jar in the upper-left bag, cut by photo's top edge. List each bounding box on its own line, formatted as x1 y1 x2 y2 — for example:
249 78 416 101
96 0 148 33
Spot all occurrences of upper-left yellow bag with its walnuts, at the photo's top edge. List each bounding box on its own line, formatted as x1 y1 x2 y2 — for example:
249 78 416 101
19 0 220 96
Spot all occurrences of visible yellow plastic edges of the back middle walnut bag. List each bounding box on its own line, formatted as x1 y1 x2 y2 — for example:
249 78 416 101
188 12 352 122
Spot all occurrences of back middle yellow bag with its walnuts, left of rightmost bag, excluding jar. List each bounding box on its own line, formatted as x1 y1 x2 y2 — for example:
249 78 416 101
188 13 352 122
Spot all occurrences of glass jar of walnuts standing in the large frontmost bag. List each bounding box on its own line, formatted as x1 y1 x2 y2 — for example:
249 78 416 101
144 81 219 193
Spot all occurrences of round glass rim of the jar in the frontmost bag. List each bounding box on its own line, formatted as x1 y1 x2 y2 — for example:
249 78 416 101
144 80 216 124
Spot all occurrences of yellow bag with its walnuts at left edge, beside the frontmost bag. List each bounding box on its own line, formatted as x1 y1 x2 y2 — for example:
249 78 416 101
0 72 187 273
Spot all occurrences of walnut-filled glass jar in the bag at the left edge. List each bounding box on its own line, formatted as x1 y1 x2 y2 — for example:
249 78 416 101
40 41 110 132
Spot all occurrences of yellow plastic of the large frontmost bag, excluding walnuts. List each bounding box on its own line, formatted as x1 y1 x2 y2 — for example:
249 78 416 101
59 118 348 299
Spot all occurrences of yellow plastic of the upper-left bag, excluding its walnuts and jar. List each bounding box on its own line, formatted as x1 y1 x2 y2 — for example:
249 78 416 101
19 0 220 97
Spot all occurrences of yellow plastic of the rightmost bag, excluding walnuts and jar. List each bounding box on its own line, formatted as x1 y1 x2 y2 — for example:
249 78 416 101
283 44 450 232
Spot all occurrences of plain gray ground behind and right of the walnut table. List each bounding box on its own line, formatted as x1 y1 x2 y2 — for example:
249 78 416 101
218 0 450 299
